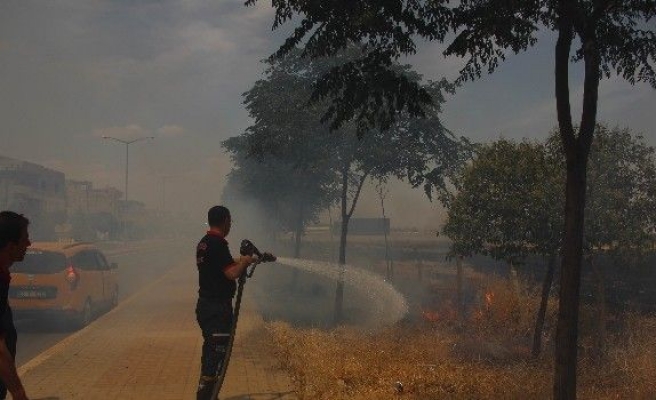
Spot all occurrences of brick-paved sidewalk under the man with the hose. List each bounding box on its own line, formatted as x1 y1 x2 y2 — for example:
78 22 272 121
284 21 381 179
18 265 296 400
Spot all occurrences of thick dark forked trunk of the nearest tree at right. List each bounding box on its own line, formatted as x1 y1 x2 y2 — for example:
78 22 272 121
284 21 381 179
553 0 600 400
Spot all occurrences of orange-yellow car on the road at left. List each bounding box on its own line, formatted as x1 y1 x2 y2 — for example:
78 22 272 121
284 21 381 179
9 242 118 328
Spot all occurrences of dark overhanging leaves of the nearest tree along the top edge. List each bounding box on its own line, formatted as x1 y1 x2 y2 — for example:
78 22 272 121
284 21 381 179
246 0 656 133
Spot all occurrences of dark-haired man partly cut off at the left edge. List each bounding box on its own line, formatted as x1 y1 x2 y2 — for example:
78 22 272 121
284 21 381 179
0 211 31 400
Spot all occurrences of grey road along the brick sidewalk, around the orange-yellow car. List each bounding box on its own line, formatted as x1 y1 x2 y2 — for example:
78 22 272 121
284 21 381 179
16 244 191 366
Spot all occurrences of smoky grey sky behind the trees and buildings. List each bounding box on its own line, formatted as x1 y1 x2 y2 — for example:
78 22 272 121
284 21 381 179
0 0 656 228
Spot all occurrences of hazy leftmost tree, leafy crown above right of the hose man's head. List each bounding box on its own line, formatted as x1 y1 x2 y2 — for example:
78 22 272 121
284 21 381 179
223 50 338 257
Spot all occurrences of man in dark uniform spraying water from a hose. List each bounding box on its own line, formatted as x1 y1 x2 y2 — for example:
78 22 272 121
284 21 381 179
196 206 254 400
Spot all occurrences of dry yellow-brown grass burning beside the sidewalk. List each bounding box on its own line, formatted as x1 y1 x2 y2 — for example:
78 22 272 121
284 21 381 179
268 280 656 400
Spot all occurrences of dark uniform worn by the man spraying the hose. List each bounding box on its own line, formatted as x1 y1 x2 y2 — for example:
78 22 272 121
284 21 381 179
196 231 237 383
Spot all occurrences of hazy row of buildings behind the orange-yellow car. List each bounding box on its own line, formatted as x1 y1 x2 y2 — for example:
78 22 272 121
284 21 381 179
0 156 149 241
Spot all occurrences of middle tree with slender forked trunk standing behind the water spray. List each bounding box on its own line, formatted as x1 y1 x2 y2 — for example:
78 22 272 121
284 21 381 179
231 46 469 322
